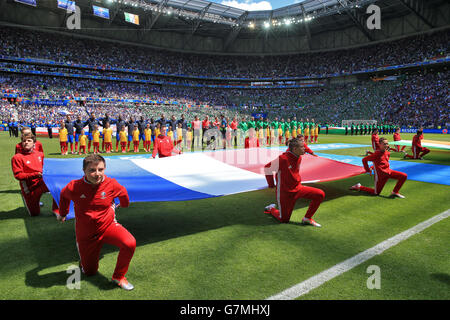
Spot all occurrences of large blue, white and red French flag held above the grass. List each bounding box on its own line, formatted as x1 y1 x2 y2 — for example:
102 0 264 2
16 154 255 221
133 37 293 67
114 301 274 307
43 148 364 218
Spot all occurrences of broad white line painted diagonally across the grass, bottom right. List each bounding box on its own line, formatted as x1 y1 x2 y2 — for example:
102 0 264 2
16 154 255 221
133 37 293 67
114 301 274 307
266 209 450 300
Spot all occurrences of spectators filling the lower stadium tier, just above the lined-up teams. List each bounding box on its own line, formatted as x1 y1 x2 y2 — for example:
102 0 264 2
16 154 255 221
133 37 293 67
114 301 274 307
0 71 450 127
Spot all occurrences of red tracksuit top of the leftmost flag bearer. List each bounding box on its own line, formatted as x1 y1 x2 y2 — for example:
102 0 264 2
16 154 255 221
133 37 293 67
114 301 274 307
11 150 44 193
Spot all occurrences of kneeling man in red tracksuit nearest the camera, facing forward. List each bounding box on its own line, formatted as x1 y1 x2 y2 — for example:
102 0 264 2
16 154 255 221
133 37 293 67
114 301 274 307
57 154 136 290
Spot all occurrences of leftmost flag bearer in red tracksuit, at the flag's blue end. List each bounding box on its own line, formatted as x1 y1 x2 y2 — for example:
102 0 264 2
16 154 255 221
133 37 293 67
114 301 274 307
11 133 58 216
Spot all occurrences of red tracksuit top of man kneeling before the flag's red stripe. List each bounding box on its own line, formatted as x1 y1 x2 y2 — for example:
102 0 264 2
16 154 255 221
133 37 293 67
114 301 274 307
265 150 302 192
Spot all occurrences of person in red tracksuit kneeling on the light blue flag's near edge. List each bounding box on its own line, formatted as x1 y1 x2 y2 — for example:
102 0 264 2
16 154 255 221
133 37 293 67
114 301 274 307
350 138 408 199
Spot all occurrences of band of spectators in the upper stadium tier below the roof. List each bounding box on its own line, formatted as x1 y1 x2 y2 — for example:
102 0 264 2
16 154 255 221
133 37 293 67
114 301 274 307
0 27 450 79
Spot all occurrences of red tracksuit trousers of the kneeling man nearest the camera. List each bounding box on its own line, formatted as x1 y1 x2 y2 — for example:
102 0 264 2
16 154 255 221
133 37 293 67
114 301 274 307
77 222 136 279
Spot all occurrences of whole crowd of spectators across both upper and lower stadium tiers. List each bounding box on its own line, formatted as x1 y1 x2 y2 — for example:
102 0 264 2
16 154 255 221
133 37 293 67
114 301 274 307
0 27 449 127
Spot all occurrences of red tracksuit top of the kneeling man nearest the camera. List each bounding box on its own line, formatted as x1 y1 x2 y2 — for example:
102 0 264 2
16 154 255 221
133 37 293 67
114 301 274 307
59 176 130 240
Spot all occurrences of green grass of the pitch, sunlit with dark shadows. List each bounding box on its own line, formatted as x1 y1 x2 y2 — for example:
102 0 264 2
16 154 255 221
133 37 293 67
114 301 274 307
0 133 450 300
